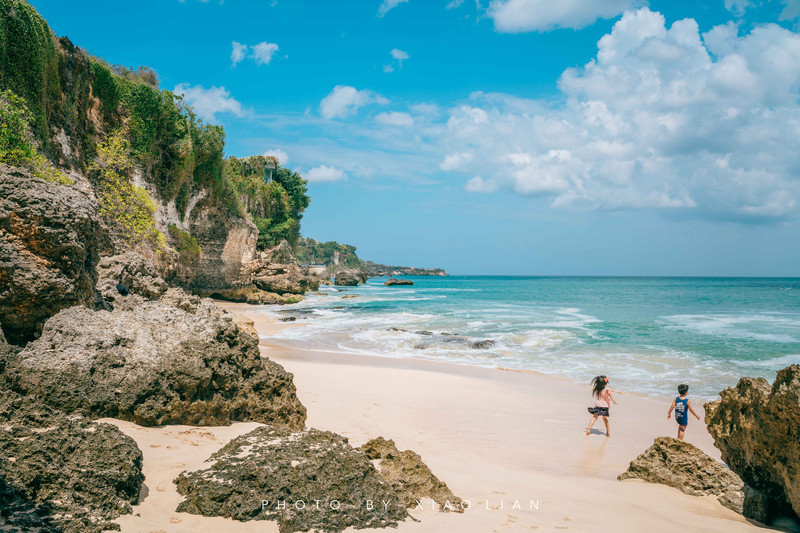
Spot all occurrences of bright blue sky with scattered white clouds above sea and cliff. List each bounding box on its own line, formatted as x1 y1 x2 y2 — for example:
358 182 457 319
31 0 800 276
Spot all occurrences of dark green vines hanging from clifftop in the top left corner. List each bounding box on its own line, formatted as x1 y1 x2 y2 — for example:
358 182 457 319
0 0 61 146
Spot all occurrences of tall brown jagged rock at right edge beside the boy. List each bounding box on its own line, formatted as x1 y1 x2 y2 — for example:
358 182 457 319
705 365 800 516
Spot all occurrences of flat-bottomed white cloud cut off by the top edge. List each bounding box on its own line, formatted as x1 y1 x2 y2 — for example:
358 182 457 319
488 0 640 33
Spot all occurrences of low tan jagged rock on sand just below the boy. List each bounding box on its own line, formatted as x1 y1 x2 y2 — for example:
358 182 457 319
618 437 770 522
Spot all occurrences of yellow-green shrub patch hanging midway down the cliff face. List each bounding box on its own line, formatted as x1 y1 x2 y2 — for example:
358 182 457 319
89 132 167 251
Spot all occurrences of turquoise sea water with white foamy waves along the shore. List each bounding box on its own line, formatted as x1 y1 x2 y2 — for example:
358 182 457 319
266 276 800 398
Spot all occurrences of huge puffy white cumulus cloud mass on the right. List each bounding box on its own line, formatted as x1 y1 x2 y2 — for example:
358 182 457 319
440 8 800 221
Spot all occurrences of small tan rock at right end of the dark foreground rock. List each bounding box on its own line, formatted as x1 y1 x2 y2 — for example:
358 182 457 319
361 437 464 513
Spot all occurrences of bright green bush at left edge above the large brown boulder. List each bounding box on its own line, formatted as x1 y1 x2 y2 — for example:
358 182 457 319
0 90 73 185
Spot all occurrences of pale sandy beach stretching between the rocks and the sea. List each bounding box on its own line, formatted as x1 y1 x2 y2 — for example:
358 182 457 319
106 304 763 533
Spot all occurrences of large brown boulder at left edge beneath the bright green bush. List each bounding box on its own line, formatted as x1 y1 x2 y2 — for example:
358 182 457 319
0 165 103 344
